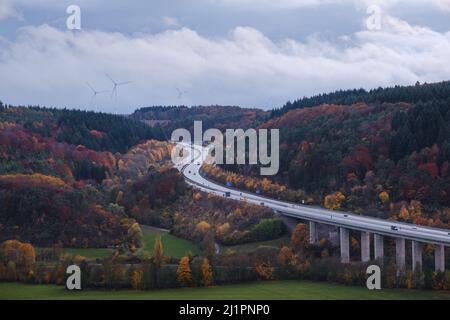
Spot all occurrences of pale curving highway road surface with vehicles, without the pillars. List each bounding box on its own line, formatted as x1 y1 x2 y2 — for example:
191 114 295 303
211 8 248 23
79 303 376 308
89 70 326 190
177 144 450 246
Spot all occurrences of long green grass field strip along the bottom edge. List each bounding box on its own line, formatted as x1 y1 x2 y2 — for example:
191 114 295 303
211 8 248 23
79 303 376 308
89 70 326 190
0 281 450 300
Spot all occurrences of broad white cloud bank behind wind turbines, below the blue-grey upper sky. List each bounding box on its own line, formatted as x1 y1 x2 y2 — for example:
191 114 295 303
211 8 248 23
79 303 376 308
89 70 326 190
0 17 450 112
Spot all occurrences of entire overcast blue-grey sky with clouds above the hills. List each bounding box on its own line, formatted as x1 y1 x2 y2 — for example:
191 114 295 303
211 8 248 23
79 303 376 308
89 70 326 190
0 0 450 113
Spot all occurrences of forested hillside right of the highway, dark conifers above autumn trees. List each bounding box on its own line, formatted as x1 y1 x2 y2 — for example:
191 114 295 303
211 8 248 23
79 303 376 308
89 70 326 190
211 83 450 226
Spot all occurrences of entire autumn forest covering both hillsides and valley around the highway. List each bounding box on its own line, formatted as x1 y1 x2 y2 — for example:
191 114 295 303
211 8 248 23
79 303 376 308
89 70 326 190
0 82 450 290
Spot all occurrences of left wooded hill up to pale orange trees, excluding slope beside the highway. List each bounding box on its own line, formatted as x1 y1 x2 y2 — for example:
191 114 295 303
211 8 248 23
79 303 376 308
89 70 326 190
0 105 174 247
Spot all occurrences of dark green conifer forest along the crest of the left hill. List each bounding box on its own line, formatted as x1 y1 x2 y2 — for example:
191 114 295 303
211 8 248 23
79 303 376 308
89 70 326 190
0 102 164 153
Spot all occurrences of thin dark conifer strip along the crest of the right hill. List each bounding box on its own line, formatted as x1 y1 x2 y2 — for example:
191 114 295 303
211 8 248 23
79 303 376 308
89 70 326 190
271 81 450 118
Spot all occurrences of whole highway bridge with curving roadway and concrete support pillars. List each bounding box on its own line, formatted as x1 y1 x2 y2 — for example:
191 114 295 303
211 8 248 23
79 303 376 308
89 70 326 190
178 144 450 273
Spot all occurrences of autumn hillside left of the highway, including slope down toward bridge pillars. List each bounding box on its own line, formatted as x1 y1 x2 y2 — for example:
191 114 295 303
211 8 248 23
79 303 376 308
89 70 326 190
0 106 284 247
